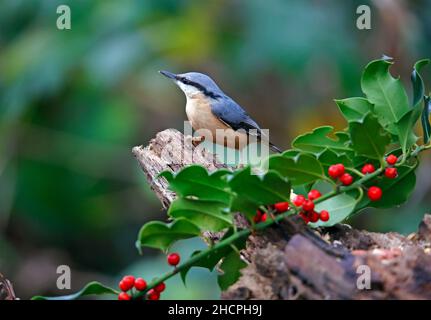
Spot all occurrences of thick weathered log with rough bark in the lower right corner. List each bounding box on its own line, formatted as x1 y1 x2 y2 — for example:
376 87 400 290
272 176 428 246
223 221 431 299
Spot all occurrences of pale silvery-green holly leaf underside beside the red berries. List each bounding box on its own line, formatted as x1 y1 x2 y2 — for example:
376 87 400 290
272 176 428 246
309 193 356 227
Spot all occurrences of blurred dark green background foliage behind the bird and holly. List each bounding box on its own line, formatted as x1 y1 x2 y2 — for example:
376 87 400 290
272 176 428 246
0 0 431 299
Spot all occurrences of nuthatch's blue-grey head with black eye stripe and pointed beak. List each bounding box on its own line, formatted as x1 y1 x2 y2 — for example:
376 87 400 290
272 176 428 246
159 71 225 99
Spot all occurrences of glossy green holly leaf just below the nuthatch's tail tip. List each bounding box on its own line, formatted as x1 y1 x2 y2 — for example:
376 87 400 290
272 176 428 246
267 153 326 186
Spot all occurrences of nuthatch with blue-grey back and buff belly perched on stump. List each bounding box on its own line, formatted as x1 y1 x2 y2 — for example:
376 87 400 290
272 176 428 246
159 70 282 153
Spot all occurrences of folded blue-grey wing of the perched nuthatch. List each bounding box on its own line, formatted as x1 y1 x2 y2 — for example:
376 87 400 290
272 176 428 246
211 97 261 136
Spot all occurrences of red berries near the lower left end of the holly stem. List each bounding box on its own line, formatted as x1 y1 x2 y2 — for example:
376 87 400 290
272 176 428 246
118 253 181 300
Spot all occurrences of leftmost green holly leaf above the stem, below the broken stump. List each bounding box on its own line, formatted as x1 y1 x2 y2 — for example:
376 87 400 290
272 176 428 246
136 219 200 252
